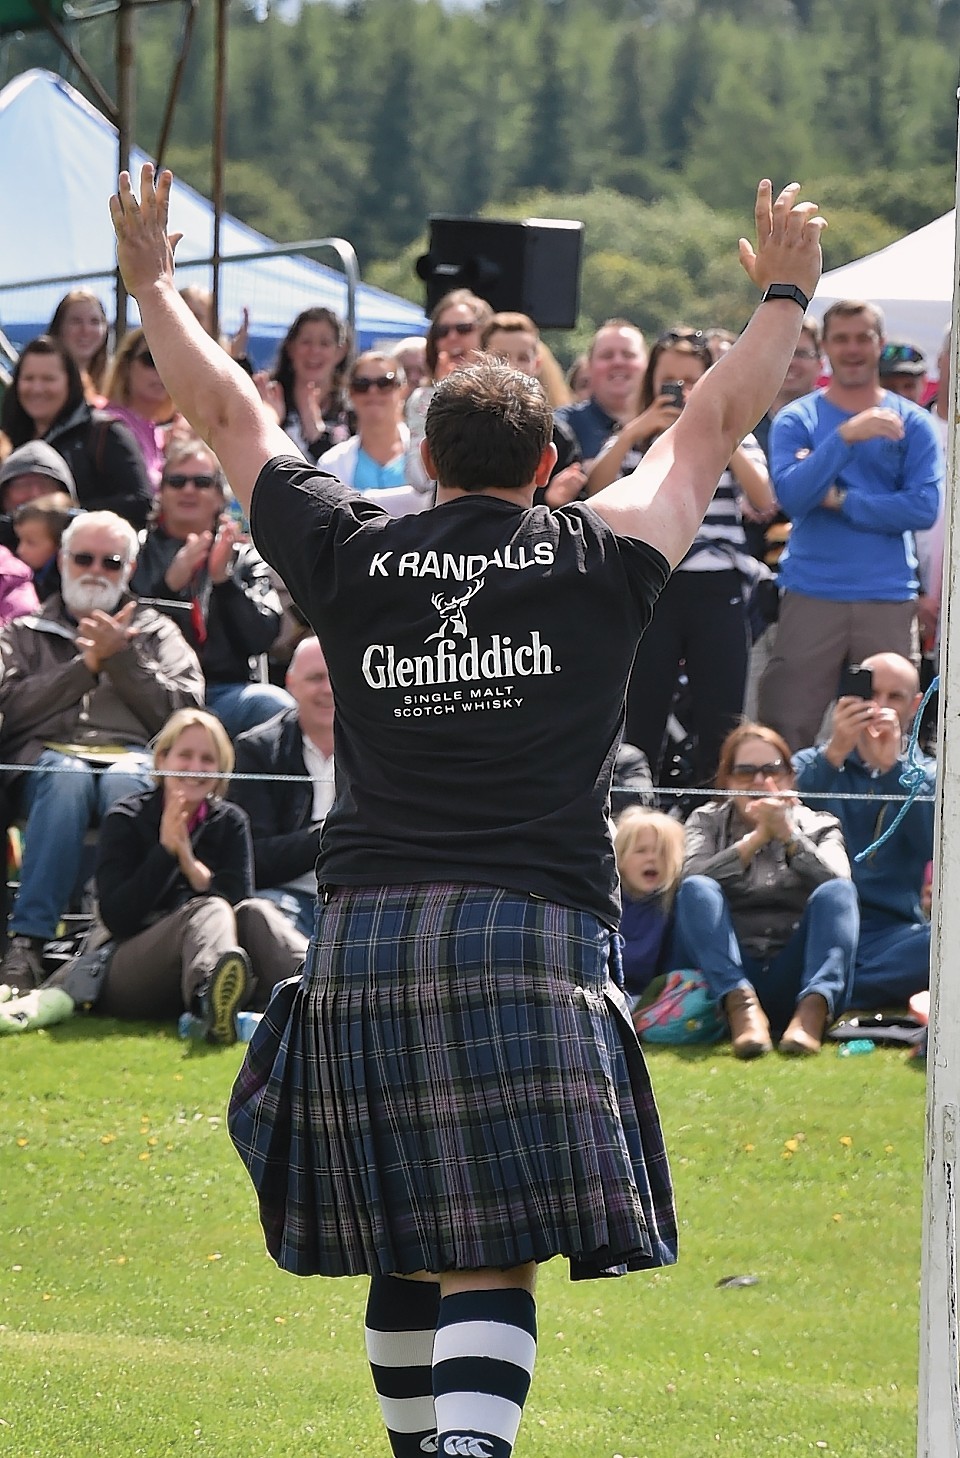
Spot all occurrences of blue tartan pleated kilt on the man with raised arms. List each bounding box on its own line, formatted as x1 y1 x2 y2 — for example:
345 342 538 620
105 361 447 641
228 884 677 1279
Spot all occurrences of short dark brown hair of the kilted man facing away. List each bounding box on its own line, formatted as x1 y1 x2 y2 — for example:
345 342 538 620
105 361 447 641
426 357 553 491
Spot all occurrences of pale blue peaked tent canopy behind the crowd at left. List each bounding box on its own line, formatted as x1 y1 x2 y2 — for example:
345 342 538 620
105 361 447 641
0 70 427 365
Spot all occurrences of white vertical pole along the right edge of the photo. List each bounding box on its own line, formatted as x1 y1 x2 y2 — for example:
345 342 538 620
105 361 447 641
916 88 960 1458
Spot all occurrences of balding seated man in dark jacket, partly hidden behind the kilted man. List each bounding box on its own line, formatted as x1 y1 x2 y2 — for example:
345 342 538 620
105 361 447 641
229 636 334 936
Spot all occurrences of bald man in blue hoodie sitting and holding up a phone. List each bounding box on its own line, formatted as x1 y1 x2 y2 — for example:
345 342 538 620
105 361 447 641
794 653 935 1009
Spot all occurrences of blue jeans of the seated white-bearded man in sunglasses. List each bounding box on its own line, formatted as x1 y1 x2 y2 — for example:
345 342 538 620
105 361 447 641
10 749 153 942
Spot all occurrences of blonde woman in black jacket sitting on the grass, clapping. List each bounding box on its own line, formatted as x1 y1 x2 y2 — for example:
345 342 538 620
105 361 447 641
96 709 308 1042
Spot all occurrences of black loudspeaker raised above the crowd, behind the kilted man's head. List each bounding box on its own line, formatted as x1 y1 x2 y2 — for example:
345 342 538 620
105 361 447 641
417 213 584 330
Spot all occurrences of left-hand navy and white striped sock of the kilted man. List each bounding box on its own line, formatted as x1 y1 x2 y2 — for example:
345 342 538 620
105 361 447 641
363 1276 441 1458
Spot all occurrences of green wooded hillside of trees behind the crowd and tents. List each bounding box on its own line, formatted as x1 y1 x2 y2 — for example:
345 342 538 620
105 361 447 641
3 0 960 353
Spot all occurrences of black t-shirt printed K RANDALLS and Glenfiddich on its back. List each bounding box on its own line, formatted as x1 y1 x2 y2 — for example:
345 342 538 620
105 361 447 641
251 456 668 924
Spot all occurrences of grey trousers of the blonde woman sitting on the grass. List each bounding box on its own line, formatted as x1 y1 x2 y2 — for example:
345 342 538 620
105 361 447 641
96 897 308 1021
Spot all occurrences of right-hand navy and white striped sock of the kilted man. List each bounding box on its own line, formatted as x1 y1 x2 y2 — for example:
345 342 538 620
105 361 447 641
433 1287 537 1458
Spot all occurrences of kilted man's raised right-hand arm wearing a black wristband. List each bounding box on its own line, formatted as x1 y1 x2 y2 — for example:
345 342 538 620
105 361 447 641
589 179 826 566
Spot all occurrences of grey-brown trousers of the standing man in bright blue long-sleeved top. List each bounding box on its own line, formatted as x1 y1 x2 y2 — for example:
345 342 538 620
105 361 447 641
757 592 919 752
